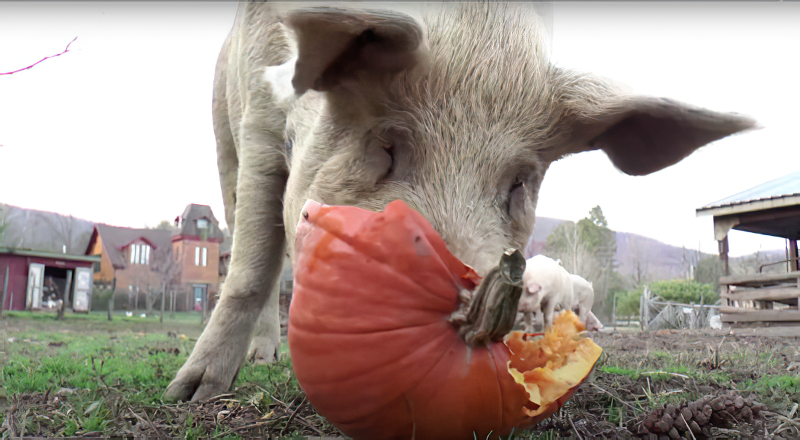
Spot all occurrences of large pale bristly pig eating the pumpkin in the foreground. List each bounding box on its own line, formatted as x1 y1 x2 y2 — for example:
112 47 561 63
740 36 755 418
165 2 754 400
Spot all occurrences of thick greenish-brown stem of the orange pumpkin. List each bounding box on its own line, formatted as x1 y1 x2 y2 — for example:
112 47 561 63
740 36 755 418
450 249 525 347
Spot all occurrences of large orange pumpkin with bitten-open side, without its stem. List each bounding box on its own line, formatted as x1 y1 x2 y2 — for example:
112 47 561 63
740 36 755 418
288 201 601 440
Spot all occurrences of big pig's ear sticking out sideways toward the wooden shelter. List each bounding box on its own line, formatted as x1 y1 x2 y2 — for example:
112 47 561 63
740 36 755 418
546 72 756 176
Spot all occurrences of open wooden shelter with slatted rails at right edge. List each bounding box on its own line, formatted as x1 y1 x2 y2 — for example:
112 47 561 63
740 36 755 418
697 171 800 326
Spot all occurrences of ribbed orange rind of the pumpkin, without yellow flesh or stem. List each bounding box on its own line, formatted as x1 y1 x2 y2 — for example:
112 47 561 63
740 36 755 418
289 202 600 440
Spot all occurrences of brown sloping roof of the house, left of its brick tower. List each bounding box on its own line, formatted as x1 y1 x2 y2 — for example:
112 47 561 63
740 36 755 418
86 224 172 269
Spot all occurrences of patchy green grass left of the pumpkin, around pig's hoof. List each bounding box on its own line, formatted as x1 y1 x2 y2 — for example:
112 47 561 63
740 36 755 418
2 312 335 439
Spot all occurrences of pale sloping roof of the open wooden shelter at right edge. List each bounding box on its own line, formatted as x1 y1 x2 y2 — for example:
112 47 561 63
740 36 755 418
697 171 800 216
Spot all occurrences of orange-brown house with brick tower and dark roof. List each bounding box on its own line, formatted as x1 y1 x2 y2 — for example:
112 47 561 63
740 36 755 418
86 204 222 311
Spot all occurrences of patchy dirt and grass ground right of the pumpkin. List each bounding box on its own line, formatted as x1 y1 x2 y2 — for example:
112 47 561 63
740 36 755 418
536 330 800 439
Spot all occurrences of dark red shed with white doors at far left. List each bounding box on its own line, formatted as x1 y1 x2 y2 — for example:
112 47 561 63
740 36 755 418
0 247 100 312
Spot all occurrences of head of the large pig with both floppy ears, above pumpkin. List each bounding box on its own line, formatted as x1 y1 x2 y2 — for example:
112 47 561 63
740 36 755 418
272 4 753 274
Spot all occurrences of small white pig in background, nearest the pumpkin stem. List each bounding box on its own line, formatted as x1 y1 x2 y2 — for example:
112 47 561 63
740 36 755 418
518 255 575 329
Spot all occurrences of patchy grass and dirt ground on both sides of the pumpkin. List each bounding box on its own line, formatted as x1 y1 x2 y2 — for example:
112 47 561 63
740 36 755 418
0 312 800 439
